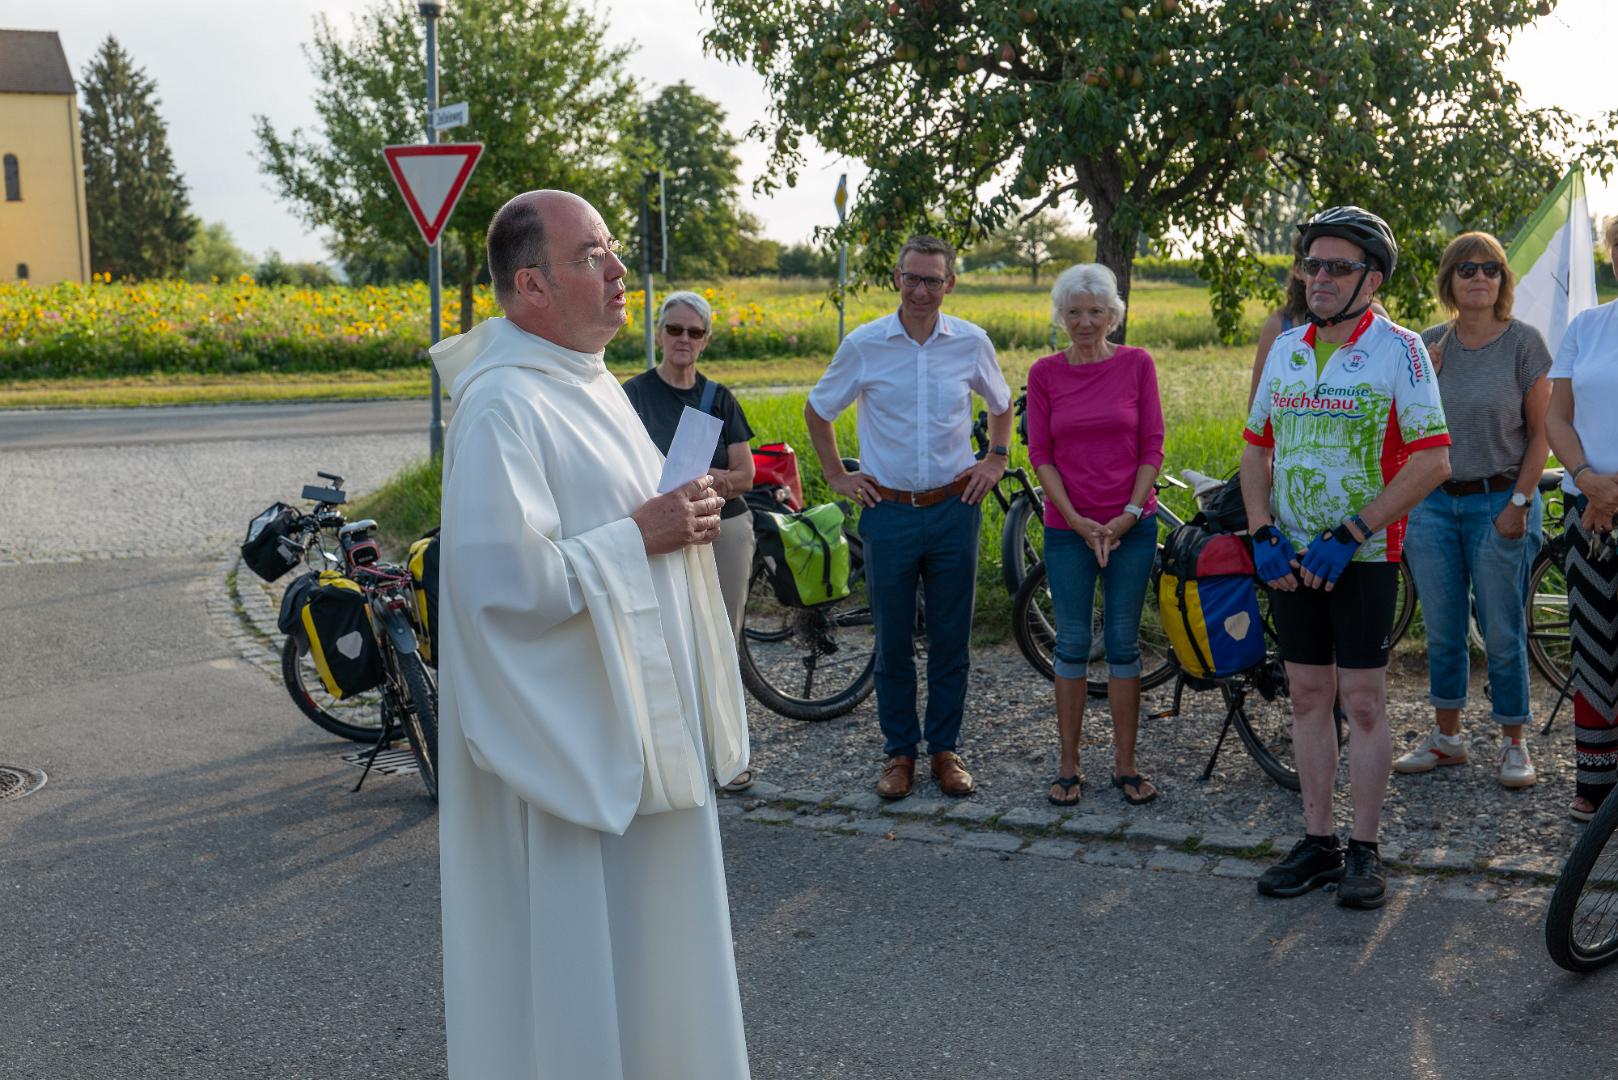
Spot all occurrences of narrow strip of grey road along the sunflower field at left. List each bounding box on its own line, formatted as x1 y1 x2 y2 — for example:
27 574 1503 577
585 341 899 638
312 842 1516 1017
0 400 453 453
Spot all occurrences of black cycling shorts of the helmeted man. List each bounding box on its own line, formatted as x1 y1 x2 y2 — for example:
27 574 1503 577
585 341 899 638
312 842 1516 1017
1270 562 1400 667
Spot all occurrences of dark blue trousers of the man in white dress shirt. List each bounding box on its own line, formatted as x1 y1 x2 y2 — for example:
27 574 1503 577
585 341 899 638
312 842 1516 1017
859 499 982 758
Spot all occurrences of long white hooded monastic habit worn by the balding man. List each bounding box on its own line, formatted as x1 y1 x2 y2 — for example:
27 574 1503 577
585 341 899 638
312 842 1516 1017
432 319 748 1080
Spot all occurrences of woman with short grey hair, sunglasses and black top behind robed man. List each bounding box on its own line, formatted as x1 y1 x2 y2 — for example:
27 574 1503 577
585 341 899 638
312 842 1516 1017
623 291 754 790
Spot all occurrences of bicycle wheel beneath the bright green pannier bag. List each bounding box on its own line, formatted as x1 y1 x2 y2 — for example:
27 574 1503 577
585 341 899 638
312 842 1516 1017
736 534 877 721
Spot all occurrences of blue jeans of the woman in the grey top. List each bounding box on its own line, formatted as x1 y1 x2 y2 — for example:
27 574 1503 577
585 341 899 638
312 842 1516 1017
1404 489 1545 724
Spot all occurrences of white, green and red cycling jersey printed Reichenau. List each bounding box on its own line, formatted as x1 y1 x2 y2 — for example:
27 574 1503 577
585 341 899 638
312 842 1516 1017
1241 309 1450 562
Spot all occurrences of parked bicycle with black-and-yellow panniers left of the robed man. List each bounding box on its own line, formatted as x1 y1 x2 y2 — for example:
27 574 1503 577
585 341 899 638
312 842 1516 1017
271 473 438 800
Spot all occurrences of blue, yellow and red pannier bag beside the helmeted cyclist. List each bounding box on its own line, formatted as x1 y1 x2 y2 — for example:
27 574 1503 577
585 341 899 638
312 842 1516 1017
1154 521 1264 678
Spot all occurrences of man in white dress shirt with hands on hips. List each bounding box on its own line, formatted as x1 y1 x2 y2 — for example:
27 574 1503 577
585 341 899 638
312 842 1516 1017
804 236 1011 798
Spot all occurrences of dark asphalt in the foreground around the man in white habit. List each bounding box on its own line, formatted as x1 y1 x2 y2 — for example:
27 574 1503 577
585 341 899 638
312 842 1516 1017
0 559 1618 1080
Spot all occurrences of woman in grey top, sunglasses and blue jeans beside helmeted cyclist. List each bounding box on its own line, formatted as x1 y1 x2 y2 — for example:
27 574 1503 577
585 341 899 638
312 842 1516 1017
1393 233 1550 787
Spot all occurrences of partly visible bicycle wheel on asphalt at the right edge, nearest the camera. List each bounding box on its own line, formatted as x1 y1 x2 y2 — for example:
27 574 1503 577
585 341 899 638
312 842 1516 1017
1545 798 1618 972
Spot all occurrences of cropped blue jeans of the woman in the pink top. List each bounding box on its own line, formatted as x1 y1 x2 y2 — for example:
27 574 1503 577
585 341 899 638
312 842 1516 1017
1045 513 1157 678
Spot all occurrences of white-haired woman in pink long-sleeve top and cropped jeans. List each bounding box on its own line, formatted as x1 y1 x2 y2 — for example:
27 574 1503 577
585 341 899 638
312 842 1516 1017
1027 262 1163 806
